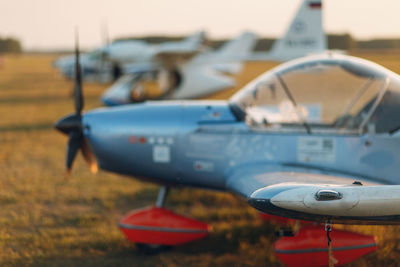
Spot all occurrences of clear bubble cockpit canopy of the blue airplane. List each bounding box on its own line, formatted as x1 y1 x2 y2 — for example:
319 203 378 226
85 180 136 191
230 54 400 133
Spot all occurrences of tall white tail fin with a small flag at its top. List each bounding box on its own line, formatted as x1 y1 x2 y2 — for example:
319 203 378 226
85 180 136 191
248 0 327 61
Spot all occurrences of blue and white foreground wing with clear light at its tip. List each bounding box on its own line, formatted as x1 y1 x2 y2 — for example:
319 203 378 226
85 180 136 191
226 166 400 224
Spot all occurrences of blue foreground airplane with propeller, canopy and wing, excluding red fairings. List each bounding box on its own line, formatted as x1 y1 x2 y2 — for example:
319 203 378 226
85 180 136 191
56 38 400 266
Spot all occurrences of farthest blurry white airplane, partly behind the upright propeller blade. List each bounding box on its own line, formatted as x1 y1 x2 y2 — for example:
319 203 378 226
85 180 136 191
54 31 205 83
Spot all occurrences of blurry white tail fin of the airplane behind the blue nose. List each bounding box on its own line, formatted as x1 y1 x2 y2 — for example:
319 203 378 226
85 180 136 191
214 32 256 60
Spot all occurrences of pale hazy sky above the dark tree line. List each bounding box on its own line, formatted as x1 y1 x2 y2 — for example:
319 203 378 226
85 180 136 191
0 0 400 50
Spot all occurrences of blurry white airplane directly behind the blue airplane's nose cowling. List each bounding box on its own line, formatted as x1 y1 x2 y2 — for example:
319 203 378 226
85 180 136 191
102 32 256 106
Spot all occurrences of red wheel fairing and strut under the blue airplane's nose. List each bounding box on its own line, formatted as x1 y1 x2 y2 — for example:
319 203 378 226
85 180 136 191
119 186 210 253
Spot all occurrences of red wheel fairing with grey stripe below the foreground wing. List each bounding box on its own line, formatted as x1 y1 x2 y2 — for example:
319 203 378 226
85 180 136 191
260 213 377 267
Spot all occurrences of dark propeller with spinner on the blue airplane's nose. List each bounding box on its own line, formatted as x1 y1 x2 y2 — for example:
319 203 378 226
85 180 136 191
55 30 98 179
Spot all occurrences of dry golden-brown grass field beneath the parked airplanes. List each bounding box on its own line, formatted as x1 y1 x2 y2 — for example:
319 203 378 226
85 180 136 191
0 52 400 266
